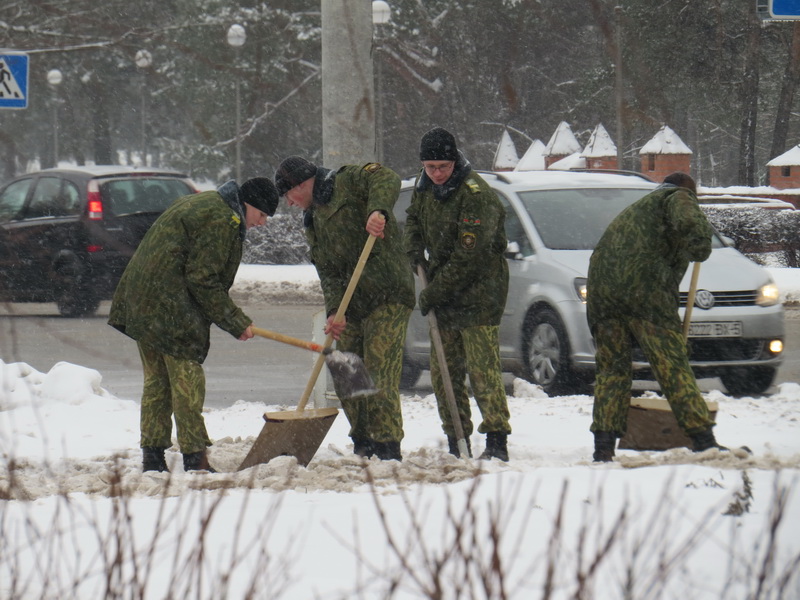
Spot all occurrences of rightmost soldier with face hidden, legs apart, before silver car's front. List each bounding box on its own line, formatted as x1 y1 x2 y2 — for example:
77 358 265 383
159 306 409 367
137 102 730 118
587 173 721 462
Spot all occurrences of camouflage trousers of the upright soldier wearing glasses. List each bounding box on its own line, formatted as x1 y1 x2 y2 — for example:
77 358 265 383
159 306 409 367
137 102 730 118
430 326 511 437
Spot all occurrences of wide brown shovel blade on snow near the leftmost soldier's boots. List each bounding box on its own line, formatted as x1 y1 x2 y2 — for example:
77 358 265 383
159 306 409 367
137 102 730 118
239 408 339 471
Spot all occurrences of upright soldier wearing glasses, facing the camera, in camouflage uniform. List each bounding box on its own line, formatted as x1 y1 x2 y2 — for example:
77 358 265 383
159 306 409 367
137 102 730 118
404 127 511 461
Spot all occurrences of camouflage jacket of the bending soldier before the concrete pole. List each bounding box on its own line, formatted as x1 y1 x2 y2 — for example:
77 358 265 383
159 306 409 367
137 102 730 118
305 163 414 322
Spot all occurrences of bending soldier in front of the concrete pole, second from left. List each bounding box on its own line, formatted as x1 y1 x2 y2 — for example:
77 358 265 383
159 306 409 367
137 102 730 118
275 156 414 460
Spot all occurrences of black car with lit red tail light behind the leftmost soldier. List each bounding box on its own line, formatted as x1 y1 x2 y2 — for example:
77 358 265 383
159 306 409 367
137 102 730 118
0 166 197 317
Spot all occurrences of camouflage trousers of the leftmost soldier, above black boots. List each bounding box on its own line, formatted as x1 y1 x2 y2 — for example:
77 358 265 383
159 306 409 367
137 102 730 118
137 343 211 454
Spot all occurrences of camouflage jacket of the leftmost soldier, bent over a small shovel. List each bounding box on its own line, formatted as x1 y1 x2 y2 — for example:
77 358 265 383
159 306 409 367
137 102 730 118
108 182 251 363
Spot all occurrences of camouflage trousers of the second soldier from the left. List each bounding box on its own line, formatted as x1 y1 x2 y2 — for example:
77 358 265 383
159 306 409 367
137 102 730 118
334 304 411 442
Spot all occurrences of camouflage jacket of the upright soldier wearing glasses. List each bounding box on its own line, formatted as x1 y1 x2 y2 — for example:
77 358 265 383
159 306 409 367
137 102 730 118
404 158 508 329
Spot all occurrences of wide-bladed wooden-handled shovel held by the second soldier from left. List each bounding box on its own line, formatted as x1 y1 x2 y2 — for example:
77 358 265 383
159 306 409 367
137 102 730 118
239 235 375 471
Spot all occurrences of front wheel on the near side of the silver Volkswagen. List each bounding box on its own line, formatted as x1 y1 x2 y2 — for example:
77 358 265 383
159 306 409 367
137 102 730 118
522 309 590 396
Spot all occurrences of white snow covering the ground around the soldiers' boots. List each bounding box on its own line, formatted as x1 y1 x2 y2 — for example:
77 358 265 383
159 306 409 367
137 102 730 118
0 265 800 599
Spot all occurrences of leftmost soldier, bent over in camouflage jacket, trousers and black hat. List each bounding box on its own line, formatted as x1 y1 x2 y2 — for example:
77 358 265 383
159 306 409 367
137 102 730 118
108 178 278 471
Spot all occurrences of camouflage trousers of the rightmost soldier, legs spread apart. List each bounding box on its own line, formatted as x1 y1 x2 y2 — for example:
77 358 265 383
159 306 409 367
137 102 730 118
591 318 714 436
